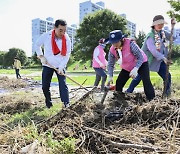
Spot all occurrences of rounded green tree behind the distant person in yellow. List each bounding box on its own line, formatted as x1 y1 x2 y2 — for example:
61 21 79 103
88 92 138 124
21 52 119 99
3 48 27 66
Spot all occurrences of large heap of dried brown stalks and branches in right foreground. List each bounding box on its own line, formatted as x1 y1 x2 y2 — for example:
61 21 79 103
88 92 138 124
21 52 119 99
39 89 180 154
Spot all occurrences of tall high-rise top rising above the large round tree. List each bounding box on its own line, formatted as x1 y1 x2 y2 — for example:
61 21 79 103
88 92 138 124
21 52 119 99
79 0 105 23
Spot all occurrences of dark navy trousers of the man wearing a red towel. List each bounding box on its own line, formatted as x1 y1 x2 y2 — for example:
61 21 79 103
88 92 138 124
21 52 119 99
42 66 69 107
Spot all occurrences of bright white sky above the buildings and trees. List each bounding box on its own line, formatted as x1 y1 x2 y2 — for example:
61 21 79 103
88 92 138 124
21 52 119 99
0 0 180 56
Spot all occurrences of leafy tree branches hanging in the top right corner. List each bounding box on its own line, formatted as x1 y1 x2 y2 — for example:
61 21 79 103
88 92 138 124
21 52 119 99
167 0 180 22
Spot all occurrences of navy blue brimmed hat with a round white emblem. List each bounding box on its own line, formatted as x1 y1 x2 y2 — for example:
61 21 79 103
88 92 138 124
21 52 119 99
108 30 126 44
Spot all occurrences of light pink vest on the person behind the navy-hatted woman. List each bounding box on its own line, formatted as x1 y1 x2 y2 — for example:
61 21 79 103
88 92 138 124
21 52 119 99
92 45 107 68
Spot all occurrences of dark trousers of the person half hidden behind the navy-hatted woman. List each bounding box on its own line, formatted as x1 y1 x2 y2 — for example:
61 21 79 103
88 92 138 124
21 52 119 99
94 68 107 91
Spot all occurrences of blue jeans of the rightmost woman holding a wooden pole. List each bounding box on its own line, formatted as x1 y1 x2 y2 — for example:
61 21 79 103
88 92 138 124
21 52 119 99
126 61 171 95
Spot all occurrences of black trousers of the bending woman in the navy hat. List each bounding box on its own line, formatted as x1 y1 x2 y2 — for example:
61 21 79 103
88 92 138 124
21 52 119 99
116 62 155 100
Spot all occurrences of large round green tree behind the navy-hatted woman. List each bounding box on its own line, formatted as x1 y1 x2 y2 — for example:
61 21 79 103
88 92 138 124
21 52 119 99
72 9 127 61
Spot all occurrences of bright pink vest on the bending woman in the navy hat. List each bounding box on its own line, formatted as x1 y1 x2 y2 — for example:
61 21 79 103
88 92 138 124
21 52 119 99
110 38 147 72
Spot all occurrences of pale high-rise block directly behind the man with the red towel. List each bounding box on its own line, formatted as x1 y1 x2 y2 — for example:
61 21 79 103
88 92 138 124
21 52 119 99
32 17 77 55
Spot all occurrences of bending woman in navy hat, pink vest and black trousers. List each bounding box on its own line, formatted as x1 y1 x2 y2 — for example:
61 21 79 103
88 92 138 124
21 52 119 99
108 30 155 101
